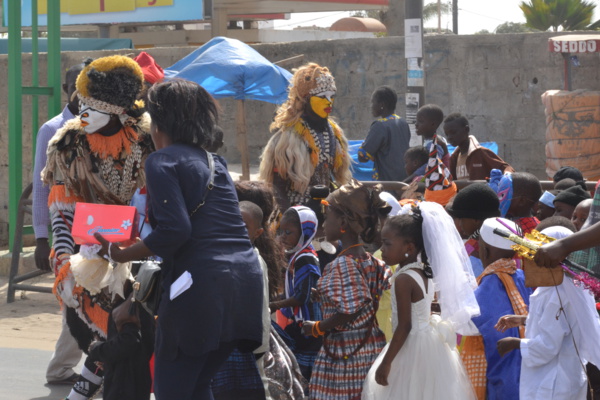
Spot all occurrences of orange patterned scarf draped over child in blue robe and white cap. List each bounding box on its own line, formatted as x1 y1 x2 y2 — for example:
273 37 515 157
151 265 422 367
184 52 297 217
460 258 527 400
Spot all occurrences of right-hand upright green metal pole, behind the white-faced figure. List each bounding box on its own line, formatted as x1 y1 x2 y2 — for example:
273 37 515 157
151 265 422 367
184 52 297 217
48 0 62 119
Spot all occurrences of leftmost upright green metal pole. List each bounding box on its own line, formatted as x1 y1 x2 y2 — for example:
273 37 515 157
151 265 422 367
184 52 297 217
8 0 23 249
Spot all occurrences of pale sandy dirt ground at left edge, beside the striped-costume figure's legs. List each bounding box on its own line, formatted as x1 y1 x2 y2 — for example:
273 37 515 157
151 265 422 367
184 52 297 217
0 273 61 351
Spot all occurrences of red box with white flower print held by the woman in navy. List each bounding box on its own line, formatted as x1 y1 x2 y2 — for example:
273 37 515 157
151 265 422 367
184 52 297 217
71 203 138 246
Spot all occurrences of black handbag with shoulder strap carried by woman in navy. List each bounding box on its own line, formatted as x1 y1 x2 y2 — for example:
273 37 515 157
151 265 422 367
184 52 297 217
132 151 215 315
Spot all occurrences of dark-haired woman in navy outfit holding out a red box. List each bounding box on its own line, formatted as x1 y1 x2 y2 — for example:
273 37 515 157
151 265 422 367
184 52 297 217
98 80 263 400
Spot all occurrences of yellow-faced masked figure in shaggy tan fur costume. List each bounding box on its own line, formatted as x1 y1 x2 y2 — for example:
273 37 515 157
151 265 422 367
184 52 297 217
260 63 352 210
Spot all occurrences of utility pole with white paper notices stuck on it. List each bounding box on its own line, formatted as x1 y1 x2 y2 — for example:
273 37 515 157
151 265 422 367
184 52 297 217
404 0 425 146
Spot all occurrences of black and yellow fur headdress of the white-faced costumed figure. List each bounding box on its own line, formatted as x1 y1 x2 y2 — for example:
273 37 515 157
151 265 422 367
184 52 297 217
76 56 144 114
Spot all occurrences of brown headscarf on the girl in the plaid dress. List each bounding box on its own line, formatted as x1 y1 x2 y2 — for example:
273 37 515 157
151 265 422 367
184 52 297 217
327 180 391 243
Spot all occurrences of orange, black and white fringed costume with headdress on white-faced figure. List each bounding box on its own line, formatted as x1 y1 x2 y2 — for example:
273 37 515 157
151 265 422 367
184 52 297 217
42 56 152 340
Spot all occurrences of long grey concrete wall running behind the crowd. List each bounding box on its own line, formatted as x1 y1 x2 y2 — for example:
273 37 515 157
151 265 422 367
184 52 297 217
0 33 600 244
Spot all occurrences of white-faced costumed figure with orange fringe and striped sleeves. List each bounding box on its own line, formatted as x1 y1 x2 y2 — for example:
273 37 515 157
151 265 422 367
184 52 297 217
42 56 151 400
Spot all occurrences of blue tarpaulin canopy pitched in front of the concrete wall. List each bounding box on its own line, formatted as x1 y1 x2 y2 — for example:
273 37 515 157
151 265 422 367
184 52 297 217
165 37 292 104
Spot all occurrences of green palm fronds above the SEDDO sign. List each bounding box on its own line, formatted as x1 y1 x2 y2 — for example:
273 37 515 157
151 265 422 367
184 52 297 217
519 0 598 32
